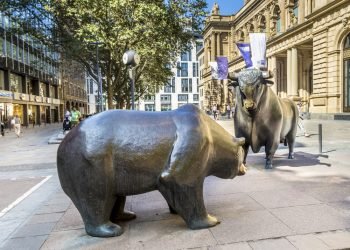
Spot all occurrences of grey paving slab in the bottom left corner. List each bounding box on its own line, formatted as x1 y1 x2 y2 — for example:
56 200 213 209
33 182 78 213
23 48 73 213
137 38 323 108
1 235 47 250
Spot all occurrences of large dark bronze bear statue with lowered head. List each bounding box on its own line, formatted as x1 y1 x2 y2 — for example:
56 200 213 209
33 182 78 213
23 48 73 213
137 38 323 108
57 105 244 237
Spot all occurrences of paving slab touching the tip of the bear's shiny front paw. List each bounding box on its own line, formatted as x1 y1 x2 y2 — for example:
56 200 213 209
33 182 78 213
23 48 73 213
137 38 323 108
210 210 293 244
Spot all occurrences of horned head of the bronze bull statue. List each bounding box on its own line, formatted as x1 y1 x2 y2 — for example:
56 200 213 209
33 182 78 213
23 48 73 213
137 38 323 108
229 69 273 112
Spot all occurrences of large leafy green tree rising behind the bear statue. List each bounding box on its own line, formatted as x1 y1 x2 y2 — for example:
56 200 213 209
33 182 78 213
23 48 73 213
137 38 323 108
2 0 206 107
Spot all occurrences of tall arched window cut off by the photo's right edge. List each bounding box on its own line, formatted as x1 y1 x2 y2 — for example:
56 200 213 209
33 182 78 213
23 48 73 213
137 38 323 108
343 34 350 112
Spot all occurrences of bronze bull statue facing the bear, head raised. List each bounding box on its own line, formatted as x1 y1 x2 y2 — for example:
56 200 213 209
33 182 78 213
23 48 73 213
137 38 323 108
229 69 299 169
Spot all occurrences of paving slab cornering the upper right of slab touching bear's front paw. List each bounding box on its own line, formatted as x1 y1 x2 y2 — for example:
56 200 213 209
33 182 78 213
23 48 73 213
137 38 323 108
249 189 320 208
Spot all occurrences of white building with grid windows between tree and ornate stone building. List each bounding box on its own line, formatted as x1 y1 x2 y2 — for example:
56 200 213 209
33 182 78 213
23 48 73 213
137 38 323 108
136 37 203 111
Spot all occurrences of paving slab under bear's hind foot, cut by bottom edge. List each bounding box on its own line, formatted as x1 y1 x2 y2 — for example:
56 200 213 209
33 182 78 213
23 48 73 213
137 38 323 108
41 229 130 250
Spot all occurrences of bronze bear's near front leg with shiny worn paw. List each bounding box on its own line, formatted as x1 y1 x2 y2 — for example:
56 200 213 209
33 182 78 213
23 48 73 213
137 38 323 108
158 177 220 229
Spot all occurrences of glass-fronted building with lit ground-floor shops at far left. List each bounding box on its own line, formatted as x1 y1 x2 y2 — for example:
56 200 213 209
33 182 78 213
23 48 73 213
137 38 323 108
0 12 61 126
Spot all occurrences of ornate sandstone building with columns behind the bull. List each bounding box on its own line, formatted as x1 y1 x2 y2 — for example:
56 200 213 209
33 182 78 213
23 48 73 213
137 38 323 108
200 0 350 118
